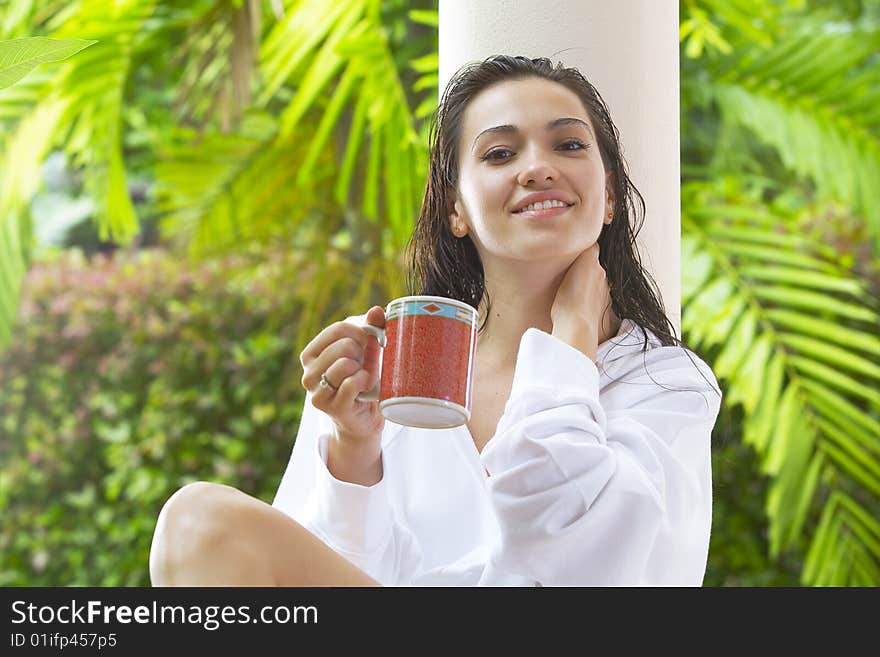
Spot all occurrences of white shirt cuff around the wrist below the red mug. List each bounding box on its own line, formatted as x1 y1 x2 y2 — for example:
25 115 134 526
313 433 392 554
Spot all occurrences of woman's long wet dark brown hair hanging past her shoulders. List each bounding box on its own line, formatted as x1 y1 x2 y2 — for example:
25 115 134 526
407 55 684 354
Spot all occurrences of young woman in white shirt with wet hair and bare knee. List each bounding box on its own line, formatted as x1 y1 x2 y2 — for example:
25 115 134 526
150 56 721 586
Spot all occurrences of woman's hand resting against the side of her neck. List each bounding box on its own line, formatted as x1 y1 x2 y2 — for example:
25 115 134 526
550 242 620 360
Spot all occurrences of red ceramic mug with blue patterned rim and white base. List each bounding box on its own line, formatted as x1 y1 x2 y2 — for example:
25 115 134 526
346 295 478 429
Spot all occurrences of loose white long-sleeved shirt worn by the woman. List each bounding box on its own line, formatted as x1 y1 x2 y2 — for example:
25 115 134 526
273 320 721 586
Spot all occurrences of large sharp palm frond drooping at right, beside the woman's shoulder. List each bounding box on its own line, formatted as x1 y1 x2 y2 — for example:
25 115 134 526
682 183 880 585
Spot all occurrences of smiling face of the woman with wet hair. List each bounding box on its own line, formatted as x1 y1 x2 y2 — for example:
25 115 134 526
449 77 613 265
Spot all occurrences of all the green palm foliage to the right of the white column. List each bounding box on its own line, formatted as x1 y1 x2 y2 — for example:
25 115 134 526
681 0 880 586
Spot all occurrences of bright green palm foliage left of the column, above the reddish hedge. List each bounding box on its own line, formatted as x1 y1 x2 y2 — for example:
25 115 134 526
0 0 437 349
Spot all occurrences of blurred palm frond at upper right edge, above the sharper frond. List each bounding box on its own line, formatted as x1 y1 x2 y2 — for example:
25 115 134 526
692 12 880 245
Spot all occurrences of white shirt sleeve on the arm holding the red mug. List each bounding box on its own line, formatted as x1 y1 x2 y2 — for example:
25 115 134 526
272 395 421 585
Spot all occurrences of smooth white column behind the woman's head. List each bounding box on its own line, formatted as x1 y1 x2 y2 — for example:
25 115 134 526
440 0 681 335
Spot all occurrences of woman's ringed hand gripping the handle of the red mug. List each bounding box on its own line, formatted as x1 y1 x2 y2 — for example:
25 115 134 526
299 306 385 449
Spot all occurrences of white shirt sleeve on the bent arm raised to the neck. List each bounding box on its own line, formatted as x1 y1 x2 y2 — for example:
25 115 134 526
480 328 721 586
